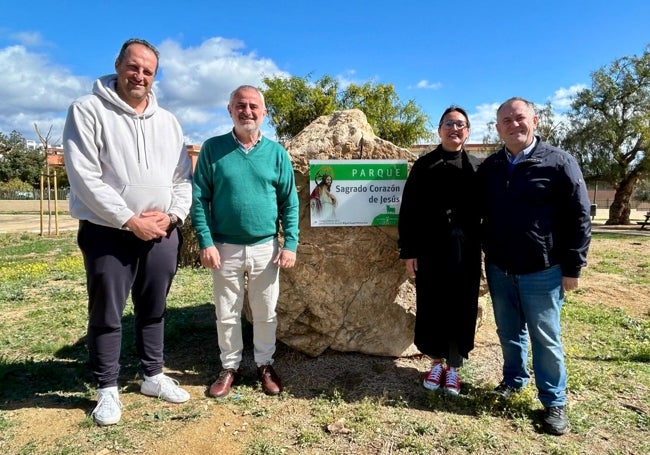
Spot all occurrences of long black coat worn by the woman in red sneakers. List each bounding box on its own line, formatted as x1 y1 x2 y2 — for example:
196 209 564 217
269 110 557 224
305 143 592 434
398 145 481 358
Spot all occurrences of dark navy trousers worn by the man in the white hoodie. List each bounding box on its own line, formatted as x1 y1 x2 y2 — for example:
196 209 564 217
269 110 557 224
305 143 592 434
77 221 181 388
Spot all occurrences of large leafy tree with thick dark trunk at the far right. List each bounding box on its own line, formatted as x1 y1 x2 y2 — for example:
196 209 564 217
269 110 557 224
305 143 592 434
563 46 650 224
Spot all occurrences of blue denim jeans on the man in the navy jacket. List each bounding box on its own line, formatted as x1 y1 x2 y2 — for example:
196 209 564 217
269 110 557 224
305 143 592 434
485 264 567 407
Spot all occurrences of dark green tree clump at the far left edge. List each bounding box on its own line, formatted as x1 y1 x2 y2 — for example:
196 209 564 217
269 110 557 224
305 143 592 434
0 131 45 189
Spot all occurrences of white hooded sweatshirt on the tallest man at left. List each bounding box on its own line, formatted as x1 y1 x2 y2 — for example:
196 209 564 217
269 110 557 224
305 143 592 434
63 74 192 228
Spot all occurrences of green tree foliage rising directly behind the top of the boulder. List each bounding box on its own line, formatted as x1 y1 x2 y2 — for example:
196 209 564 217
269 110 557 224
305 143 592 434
263 75 435 147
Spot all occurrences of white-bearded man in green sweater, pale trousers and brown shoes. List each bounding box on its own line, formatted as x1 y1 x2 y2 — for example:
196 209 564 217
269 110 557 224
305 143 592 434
191 85 299 398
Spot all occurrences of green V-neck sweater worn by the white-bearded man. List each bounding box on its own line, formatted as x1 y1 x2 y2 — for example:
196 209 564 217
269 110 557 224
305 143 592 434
190 132 299 252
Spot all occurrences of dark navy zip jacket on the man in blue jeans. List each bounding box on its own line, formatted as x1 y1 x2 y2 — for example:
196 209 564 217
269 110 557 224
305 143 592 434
478 137 591 278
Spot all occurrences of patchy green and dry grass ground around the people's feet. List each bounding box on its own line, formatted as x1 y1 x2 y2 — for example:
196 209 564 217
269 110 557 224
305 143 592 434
0 233 650 455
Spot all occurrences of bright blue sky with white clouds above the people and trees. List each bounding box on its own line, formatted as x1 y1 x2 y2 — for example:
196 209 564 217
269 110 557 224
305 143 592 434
0 0 650 145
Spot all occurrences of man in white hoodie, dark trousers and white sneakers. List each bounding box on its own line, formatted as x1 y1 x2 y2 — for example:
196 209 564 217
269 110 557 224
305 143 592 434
63 39 192 425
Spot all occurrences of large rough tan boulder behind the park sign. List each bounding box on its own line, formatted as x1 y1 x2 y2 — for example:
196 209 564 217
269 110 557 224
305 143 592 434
278 109 418 356
